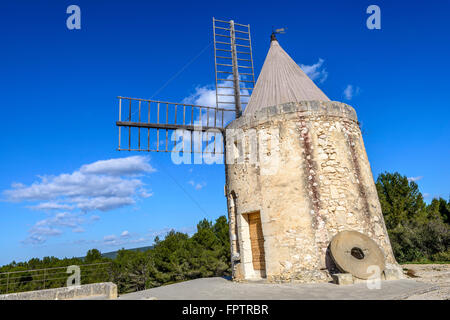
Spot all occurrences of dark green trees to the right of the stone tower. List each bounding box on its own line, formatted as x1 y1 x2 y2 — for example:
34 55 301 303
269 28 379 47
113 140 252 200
376 172 450 262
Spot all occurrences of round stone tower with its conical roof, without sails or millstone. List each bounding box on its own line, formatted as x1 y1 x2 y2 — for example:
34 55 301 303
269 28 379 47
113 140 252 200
225 37 398 282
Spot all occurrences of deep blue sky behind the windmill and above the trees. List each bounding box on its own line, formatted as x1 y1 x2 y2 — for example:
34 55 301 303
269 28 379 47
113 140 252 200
0 0 450 264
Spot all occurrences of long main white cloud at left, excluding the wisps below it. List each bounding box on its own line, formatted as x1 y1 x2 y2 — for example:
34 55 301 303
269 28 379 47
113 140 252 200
3 157 154 211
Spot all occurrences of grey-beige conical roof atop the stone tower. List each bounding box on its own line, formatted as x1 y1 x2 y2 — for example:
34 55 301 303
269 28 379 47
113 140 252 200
244 39 330 115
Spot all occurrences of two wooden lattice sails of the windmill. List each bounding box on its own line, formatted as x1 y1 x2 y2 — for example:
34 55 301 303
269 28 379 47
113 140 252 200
116 18 255 154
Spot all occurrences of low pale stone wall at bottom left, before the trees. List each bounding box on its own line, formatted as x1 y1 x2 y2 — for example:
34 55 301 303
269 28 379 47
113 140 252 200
0 282 117 300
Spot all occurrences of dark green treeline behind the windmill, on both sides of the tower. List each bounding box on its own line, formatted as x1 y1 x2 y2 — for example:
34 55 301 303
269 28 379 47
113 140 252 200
0 173 450 293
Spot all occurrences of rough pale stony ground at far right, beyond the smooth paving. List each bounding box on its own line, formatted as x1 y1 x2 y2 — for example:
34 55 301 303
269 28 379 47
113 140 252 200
402 264 450 300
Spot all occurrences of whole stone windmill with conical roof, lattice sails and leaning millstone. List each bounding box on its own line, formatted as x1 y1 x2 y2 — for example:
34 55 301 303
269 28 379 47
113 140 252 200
116 18 403 283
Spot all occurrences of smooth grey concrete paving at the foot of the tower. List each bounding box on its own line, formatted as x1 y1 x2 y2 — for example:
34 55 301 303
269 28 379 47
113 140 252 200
119 278 436 300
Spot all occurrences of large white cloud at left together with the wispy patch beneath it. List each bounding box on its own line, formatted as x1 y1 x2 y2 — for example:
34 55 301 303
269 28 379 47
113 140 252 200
3 156 155 244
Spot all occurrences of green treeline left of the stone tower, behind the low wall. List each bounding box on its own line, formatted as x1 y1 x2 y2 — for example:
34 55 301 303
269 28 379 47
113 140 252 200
0 216 230 293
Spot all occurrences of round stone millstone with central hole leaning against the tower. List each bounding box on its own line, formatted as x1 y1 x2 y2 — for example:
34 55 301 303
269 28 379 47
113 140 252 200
330 231 385 279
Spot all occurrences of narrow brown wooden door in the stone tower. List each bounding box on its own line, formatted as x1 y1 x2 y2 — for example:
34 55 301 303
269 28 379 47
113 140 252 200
248 212 266 270
